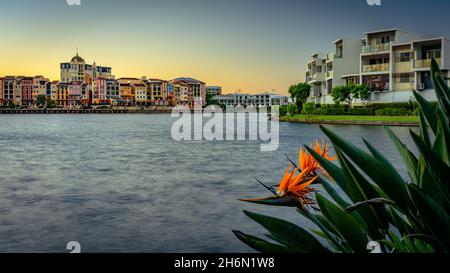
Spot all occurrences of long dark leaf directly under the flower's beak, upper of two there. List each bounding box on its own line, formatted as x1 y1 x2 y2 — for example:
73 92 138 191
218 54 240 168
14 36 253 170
244 211 329 253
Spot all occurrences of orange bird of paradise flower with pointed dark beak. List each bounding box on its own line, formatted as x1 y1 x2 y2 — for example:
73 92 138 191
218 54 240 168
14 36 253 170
240 141 336 211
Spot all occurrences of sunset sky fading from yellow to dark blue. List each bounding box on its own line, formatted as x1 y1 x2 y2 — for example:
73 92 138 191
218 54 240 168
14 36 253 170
0 0 450 94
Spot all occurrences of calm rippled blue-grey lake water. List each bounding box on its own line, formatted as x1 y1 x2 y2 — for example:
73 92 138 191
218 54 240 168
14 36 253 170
0 115 416 253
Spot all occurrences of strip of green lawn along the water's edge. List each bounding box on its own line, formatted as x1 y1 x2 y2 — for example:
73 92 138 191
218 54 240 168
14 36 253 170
280 115 419 123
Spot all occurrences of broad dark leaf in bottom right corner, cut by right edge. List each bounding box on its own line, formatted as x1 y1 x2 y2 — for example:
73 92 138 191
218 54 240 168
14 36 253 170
408 184 450 252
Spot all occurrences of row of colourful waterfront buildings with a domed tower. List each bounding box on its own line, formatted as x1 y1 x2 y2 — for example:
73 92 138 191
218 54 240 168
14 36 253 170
0 53 208 107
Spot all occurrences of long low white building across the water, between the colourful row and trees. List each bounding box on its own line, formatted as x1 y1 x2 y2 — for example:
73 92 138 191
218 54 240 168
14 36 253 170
213 93 289 107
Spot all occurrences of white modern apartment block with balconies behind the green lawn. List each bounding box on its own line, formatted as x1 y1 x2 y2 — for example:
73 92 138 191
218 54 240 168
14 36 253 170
306 29 450 104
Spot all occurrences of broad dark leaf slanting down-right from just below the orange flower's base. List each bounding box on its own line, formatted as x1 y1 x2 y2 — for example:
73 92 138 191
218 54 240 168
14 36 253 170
316 194 368 253
